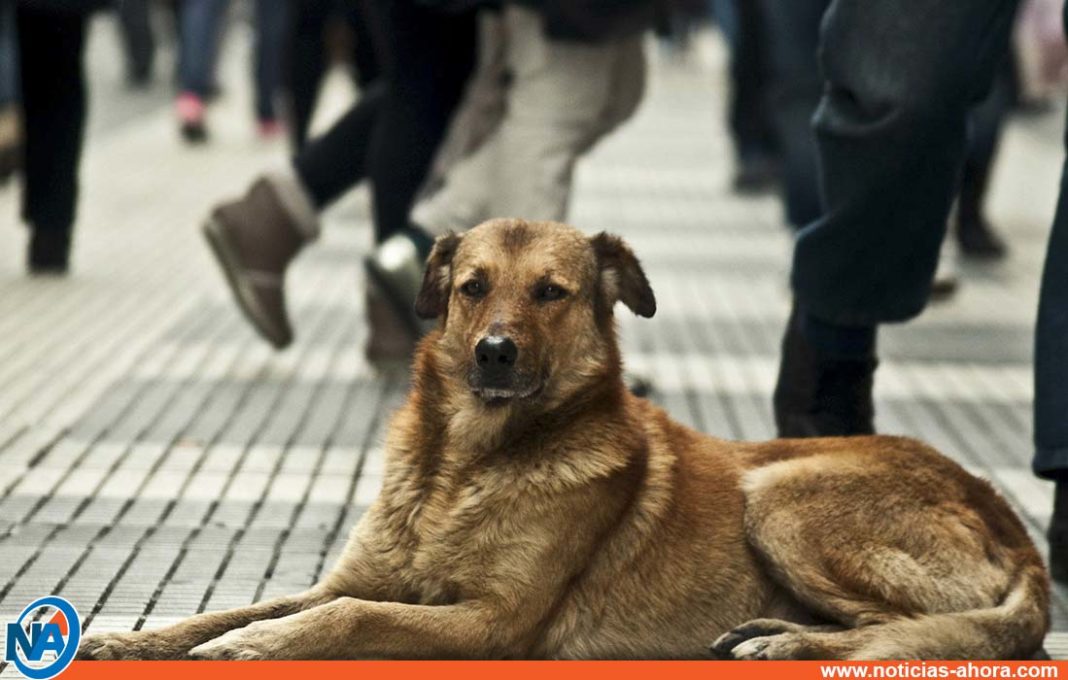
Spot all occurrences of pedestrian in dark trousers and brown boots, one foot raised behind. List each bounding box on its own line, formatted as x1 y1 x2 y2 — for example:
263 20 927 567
199 0 476 359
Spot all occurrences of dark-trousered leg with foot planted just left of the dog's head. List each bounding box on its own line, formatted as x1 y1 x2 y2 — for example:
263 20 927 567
364 0 477 360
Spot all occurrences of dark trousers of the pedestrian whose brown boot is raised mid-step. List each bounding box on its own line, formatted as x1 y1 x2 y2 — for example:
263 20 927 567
294 0 477 241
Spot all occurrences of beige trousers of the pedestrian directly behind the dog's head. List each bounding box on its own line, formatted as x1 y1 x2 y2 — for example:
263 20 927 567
413 6 645 234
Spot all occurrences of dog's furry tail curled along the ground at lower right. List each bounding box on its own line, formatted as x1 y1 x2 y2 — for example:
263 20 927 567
850 554 1050 659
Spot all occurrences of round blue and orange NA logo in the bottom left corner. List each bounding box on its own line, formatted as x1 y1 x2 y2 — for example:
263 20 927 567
4 596 81 680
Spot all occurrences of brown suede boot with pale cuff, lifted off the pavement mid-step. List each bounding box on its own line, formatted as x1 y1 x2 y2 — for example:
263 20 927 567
203 171 318 349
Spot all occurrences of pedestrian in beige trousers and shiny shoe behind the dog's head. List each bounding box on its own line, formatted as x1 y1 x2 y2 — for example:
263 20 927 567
366 0 655 339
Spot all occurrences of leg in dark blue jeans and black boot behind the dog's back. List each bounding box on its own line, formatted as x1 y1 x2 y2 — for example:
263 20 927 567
774 0 1016 437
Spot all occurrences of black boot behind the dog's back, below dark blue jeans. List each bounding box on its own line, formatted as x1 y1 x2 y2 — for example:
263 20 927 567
773 307 879 438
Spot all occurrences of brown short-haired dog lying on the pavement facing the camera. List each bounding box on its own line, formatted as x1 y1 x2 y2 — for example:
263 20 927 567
81 220 1049 659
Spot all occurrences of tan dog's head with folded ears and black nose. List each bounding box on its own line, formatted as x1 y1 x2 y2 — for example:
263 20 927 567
415 219 656 412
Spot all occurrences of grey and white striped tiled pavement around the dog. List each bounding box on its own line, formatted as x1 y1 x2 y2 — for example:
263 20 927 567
0 20 1068 676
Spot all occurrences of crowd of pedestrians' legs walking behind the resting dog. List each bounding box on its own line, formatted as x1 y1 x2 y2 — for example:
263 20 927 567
6 0 1068 582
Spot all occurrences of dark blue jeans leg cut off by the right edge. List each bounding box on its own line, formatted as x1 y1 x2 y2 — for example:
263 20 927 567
1032 5 1068 479
